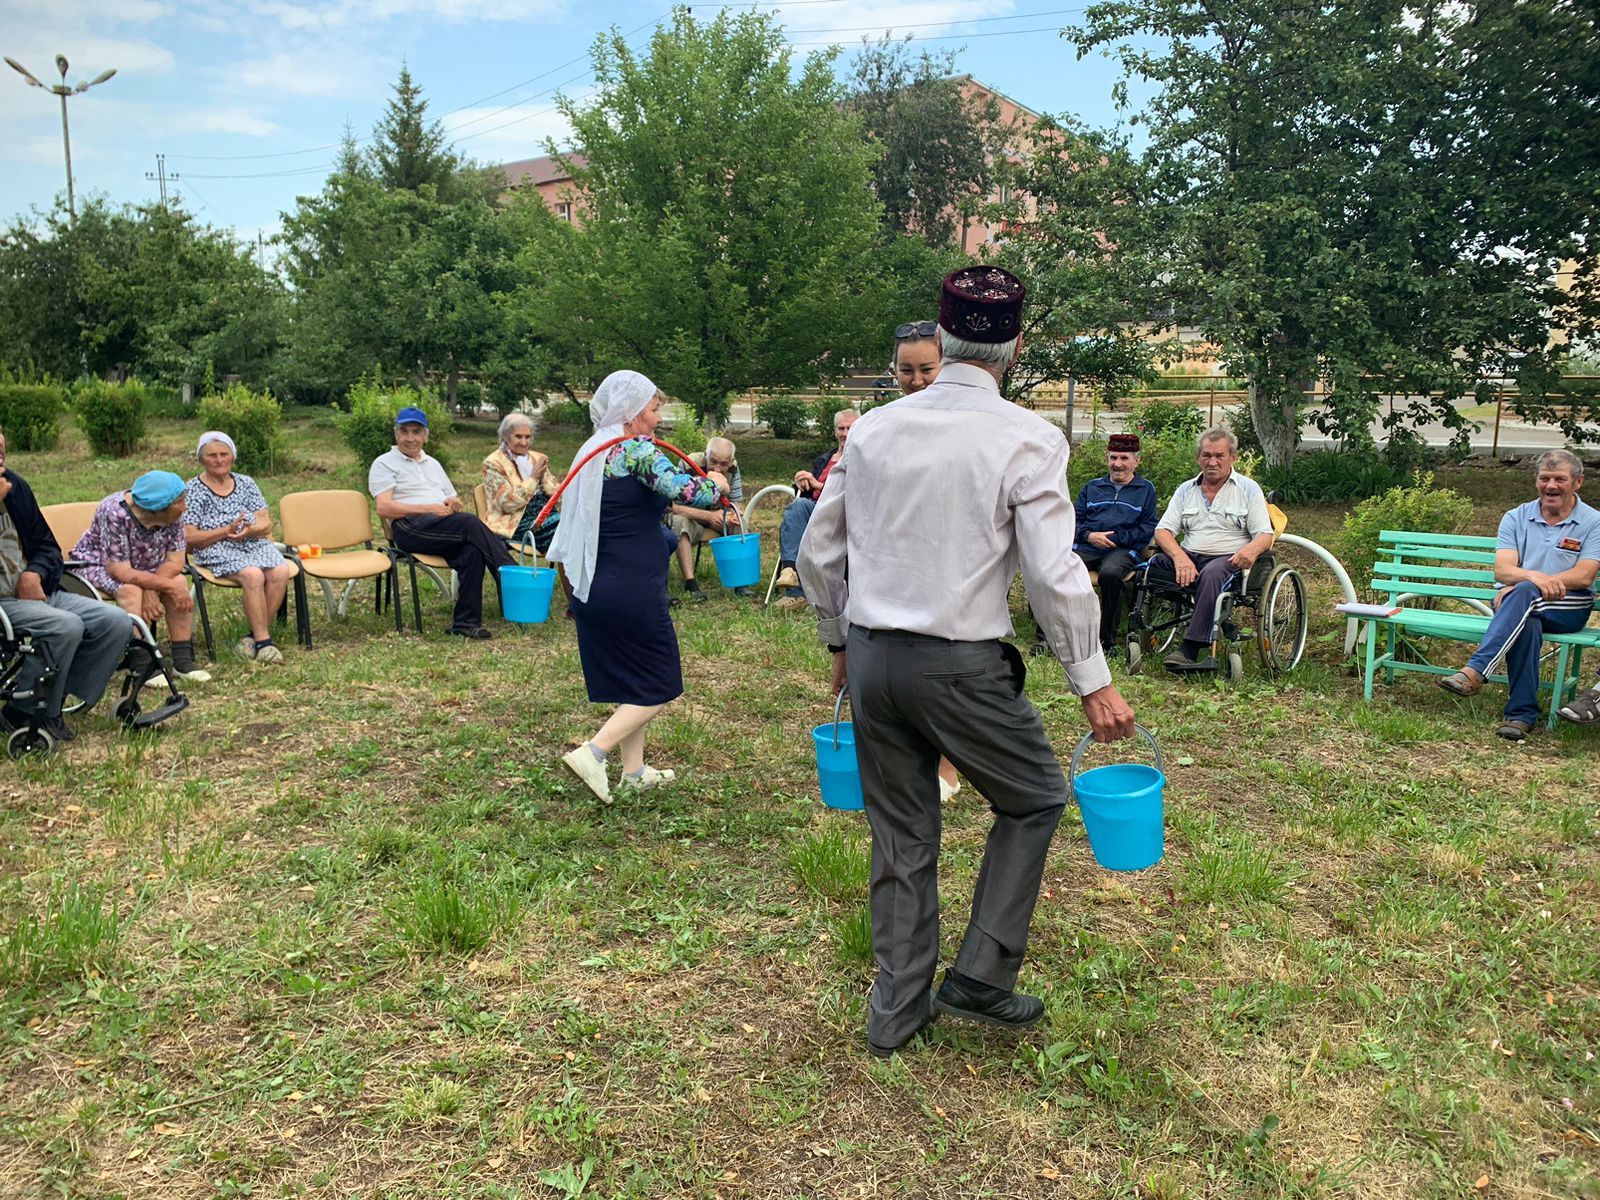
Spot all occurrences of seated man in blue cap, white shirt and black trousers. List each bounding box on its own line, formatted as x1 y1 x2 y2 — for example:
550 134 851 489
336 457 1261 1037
366 408 512 638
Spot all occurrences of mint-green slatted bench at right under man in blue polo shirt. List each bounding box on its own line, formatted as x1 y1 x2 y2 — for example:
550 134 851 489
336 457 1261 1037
1362 530 1600 728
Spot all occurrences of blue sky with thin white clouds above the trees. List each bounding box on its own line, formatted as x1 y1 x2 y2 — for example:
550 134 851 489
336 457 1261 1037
0 0 1145 240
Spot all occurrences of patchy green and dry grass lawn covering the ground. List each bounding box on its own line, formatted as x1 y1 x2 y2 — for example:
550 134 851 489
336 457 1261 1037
0 413 1600 1200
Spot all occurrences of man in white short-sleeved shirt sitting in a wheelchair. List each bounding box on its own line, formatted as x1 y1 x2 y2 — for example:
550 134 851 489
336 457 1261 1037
1150 426 1272 672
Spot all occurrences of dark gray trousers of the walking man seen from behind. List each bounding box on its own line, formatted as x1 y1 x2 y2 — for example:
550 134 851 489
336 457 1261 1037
848 626 1067 1045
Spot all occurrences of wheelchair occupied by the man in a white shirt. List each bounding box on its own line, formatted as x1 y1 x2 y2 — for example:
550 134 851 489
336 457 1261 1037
1128 504 1307 680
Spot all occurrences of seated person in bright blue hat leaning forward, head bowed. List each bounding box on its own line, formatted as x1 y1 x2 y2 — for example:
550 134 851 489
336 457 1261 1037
67 470 211 683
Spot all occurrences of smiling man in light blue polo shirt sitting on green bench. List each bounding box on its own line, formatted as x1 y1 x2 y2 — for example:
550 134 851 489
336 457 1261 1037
1438 450 1600 742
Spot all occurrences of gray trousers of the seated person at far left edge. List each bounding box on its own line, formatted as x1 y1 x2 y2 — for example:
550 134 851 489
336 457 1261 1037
0 590 133 718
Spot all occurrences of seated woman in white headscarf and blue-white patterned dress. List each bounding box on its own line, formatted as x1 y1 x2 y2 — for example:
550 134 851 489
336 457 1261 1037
184 429 294 664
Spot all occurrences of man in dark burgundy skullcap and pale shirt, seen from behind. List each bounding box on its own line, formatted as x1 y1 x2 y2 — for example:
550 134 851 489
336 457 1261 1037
797 267 1133 1058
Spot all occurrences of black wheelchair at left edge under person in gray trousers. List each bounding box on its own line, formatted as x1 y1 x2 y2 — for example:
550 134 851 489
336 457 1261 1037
0 592 189 758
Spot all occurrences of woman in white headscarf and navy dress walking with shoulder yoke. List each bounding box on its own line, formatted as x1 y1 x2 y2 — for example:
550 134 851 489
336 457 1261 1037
549 371 728 803
